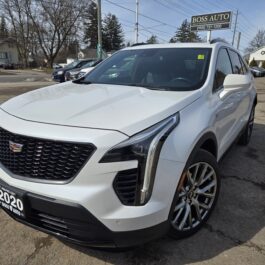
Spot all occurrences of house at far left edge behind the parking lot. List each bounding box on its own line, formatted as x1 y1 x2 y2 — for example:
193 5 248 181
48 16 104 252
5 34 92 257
0 38 19 67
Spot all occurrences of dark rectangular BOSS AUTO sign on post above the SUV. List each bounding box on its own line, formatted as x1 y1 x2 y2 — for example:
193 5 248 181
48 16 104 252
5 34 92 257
190 11 232 31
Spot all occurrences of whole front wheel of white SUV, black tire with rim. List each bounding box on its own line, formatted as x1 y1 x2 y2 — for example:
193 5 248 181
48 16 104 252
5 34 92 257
169 149 220 239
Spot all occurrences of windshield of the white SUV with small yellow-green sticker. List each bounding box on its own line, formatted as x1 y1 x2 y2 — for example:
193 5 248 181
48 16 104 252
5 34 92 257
80 48 211 91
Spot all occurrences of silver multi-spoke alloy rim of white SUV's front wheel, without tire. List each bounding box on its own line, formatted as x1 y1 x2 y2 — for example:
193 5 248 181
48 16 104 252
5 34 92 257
171 162 218 231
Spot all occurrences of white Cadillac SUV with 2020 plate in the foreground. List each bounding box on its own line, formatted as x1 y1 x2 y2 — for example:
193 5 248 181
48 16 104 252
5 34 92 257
0 42 257 247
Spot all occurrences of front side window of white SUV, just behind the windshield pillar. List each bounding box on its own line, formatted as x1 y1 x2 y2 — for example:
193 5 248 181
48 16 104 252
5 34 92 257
214 49 233 91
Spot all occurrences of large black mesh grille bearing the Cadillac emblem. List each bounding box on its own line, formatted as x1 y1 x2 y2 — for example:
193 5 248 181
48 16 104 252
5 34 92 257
0 128 96 181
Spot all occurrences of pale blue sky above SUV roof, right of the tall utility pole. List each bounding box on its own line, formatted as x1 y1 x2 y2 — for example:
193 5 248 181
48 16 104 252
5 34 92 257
101 0 265 54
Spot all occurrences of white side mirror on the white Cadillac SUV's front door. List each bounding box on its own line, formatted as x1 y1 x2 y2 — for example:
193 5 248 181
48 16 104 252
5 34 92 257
223 74 251 90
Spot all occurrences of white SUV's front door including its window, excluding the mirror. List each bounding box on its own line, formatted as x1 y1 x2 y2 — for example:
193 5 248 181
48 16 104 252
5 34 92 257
211 48 246 156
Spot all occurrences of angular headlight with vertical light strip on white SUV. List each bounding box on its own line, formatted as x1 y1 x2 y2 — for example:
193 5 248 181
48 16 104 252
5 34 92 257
100 113 179 205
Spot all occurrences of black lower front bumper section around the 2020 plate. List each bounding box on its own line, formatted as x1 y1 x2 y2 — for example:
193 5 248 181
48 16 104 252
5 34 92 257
0 177 170 248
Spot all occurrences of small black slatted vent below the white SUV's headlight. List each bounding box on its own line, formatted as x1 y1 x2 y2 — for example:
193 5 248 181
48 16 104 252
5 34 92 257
113 168 139 206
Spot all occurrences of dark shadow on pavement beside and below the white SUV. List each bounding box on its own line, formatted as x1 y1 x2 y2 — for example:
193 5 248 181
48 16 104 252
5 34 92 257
60 124 265 265
